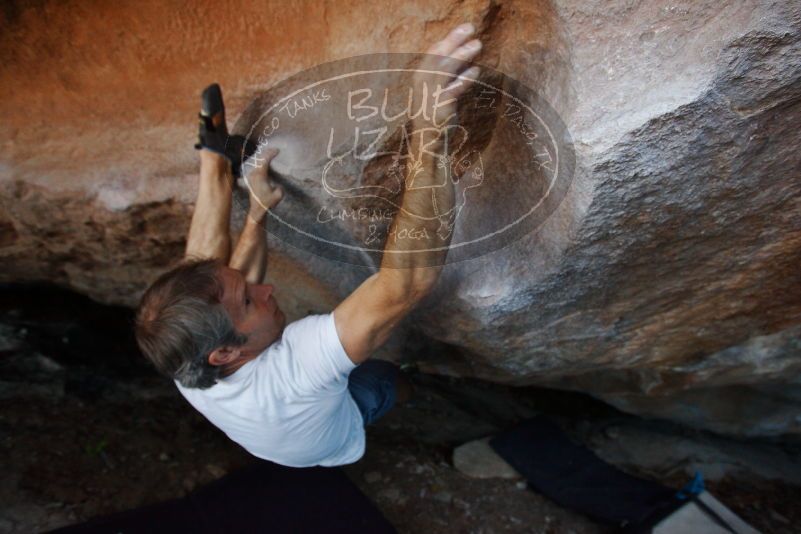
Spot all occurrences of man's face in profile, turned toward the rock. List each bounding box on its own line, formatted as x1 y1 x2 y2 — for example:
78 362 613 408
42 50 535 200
218 267 286 357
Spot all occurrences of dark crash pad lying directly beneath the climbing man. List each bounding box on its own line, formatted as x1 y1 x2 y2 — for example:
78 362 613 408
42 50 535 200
53 461 395 534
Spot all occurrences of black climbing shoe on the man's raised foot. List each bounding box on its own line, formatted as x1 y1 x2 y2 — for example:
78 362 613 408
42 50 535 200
195 83 256 178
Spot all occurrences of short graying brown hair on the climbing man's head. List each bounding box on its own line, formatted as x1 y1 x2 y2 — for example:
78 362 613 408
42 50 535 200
135 260 247 388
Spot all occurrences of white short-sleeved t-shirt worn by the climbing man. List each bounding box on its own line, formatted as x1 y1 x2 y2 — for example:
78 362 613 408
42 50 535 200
176 313 365 467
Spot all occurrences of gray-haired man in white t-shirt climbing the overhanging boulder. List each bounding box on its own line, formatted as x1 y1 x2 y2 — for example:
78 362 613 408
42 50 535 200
136 24 481 467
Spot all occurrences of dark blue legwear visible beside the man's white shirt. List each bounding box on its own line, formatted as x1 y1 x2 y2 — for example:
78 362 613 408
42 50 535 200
348 360 398 425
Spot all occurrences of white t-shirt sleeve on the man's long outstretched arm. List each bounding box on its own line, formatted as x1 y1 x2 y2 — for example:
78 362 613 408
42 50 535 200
284 313 356 393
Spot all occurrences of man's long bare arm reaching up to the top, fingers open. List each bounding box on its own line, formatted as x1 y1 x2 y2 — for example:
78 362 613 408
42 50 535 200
334 26 481 364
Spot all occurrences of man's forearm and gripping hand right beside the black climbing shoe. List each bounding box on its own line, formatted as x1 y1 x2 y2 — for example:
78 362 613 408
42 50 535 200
229 149 283 284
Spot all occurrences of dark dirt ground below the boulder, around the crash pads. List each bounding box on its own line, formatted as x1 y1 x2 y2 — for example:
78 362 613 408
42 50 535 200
0 374 801 533
